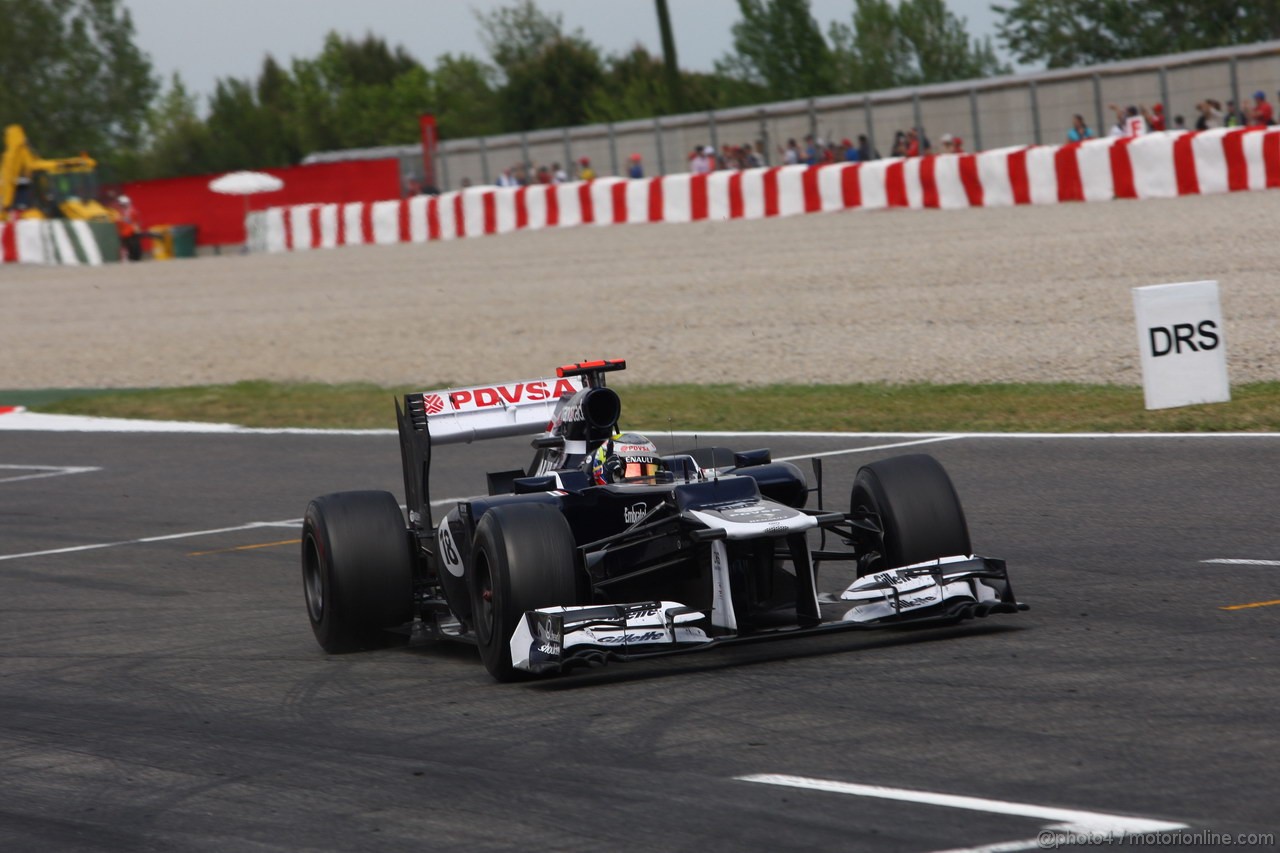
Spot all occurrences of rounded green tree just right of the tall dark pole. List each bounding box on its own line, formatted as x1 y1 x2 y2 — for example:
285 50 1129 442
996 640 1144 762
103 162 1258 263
716 0 836 100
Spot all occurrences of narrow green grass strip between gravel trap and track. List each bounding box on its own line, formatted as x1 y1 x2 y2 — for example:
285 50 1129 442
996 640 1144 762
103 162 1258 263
10 382 1280 433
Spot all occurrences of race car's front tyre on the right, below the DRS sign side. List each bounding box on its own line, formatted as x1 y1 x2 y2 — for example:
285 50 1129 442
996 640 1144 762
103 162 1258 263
849 453 972 576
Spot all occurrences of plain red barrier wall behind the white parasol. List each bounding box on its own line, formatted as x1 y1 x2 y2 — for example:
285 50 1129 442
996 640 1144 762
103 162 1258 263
119 158 401 246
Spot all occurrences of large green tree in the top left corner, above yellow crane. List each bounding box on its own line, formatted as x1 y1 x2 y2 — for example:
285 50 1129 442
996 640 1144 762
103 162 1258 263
0 0 159 160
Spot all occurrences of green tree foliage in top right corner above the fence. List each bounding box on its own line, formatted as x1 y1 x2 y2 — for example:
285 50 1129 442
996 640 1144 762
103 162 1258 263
992 0 1280 68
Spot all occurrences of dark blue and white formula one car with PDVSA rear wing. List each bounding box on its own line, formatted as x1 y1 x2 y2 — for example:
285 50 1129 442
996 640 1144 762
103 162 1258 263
302 360 1027 680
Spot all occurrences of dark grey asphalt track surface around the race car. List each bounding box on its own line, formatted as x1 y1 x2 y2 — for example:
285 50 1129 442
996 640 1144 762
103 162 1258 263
0 432 1280 852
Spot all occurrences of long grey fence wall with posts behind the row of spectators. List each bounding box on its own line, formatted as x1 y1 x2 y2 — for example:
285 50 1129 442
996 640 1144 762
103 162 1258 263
303 41 1280 191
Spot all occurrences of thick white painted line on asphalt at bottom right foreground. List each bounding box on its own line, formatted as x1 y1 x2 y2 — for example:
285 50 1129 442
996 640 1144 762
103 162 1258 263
735 774 1187 835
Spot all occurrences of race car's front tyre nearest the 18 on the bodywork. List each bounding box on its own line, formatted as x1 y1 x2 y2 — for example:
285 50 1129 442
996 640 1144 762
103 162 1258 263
471 503 579 681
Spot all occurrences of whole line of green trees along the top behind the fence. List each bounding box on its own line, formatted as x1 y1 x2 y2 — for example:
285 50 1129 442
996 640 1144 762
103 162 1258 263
0 0 1280 181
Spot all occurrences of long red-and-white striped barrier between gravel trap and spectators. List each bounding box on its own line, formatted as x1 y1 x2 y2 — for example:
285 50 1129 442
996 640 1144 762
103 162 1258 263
249 127 1280 252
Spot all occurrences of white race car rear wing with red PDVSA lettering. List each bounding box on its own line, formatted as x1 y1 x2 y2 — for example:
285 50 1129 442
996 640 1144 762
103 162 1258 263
396 374 586 529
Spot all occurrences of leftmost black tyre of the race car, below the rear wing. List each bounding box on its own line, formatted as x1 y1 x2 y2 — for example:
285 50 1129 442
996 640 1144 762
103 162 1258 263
302 492 413 654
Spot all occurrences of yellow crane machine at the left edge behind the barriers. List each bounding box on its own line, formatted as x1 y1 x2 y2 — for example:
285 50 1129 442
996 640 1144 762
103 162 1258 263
0 124 119 222
